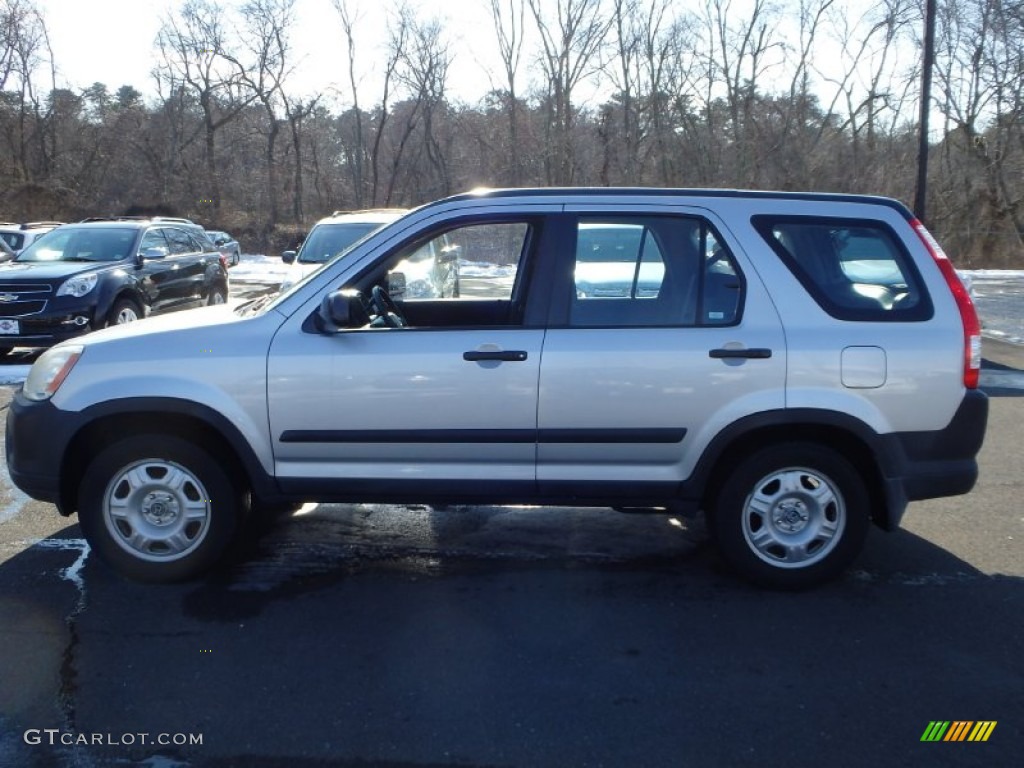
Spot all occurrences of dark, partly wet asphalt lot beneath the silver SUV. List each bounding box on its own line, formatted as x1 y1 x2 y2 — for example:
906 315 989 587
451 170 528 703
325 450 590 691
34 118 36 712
0 354 1024 768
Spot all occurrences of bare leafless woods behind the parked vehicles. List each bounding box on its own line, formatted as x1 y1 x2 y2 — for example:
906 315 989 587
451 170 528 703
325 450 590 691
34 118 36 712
0 0 1024 268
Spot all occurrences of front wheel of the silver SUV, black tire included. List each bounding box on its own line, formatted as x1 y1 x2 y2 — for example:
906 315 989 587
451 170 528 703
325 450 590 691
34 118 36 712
78 434 244 582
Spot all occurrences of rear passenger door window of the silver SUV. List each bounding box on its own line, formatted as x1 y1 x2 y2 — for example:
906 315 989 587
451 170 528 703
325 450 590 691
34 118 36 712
569 216 742 327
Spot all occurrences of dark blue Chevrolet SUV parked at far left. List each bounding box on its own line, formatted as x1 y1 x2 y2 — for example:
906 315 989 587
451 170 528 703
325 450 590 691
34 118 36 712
0 219 227 355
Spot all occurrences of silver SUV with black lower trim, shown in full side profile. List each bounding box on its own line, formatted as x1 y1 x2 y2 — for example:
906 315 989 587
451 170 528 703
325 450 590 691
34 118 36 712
7 189 987 588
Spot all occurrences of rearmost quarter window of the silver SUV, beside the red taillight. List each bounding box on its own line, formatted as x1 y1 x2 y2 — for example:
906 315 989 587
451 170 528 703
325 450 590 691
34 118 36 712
753 216 932 322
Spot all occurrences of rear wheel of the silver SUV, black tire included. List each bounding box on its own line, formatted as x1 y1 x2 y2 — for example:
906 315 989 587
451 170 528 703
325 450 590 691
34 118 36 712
709 442 869 589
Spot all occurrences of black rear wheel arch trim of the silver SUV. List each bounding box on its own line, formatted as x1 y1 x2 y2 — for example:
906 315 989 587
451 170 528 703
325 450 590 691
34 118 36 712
694 409 906 530
